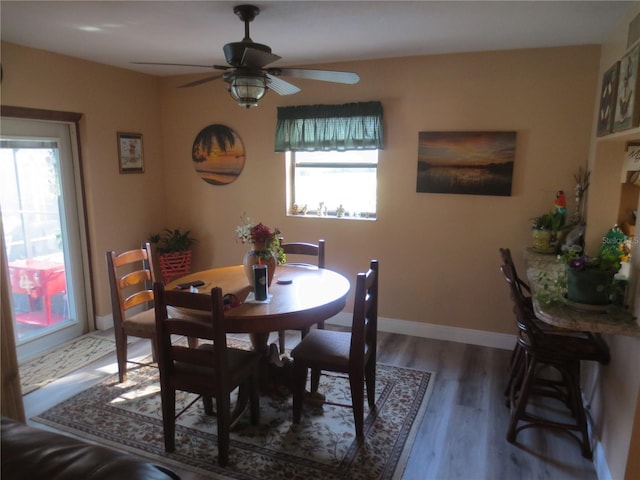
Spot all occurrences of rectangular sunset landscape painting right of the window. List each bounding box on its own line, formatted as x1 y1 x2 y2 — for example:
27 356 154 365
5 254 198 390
416 132 516 197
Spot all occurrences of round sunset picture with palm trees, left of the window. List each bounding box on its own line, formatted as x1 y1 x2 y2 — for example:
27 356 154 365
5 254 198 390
191 124 246 185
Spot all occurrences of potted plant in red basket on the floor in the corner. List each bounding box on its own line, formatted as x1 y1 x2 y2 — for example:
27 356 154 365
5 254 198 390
149 228 196 283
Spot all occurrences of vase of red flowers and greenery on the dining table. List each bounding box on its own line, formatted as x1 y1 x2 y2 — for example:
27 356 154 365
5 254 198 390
236 216 285 287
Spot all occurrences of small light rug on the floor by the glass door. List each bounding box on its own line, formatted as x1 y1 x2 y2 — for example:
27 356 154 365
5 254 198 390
19 334 116 395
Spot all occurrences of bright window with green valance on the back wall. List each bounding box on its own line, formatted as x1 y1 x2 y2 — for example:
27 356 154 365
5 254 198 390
275 102 382 219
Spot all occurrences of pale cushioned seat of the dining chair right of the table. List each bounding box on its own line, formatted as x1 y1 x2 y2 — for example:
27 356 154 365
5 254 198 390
291 330 367 372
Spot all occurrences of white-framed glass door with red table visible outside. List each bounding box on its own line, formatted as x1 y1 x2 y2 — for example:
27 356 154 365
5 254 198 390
0 118 87 361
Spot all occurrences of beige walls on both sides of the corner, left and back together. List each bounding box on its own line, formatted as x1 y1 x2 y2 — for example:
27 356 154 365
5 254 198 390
2 44 599 333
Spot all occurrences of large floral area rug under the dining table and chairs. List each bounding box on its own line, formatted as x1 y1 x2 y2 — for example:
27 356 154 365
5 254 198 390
32 340 433 480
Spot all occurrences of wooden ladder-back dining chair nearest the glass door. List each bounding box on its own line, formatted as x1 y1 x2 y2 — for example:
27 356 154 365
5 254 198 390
107 243 156 382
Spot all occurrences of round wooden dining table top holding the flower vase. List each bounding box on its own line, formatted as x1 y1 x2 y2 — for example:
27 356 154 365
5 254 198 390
166 265 351 333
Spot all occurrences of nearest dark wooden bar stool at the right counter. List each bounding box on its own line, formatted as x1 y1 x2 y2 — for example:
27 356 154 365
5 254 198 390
500 258 610 458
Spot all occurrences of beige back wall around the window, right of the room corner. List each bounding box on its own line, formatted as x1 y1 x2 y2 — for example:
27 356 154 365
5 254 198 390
162 47 599 332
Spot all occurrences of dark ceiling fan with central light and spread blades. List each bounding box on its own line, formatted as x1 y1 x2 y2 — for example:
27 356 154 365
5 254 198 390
134 5 360 108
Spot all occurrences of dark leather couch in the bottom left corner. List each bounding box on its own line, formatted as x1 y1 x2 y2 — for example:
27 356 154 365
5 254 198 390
0 417 180 480
